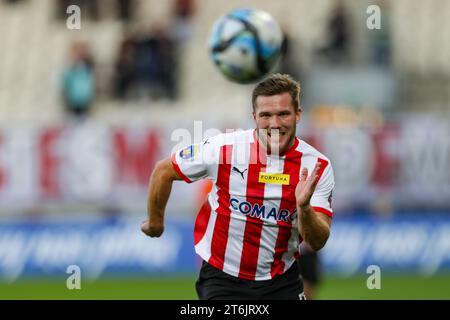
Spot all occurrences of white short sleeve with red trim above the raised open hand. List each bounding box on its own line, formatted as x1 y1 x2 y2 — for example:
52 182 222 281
310 159 334 217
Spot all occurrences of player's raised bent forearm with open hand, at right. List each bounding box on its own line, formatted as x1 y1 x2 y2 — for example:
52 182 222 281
295 163 331 251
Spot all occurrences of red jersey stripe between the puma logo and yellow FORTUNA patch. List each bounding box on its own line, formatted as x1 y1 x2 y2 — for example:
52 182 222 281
239 139 266 280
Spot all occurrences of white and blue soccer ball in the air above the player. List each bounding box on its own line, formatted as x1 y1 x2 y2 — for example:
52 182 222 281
209 8 283 83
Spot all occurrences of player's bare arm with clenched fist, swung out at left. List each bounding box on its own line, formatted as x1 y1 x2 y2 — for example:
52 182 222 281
141 158 182 237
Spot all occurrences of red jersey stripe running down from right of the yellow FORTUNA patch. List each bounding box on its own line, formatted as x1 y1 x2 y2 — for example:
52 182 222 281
270 149 302 278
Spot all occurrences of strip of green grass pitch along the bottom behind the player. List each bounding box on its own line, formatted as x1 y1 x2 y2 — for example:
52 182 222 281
0 274 450 300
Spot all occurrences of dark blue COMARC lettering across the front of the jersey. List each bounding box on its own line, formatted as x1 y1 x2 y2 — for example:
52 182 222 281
230 198 297 222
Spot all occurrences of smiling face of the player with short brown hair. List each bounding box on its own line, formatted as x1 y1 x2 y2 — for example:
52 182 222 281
253 92 301 153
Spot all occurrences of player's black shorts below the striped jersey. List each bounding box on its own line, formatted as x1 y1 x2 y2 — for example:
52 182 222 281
195 261 304 300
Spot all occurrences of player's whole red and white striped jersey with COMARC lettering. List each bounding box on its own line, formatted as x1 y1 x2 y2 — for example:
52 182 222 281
172 130 334 280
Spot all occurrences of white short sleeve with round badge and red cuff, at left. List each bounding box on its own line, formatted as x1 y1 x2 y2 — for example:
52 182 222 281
171 139 216 183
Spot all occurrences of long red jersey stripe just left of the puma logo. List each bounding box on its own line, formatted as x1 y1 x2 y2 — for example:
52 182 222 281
208 145 233 270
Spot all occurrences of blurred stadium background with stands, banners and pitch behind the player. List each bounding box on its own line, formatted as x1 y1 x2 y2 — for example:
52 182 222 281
0 0 450 299
